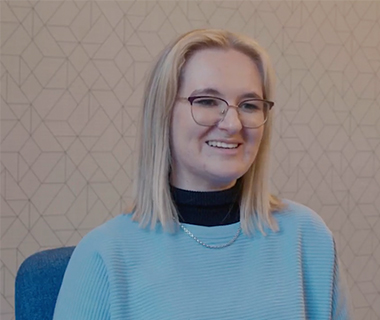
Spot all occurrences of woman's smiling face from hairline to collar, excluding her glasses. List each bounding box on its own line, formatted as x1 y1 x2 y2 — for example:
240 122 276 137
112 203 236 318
170 49 264 191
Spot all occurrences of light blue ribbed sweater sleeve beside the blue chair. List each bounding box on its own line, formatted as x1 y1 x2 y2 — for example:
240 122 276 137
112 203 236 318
53 237 110 320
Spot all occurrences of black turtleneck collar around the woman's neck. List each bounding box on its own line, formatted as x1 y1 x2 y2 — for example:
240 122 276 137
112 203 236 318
171 181 240 227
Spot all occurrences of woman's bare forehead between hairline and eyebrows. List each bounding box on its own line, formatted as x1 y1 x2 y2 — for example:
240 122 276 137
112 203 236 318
180 49 262 95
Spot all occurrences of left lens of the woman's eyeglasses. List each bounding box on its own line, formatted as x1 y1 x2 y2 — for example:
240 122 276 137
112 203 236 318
191 97 228 126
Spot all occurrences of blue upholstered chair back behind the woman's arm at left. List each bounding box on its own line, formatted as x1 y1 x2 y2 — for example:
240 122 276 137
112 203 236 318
15 247 74 320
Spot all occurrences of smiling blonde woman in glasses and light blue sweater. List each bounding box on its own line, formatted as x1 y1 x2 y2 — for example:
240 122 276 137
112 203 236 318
54 30 349 320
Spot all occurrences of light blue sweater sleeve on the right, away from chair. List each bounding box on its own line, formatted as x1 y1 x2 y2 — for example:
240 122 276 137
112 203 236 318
301 205 353 320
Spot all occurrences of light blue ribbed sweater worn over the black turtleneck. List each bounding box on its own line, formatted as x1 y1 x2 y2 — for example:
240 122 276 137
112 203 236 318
54 202 351 320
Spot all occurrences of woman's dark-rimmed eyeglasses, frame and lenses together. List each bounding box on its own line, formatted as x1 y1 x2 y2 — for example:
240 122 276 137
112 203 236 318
178 96 274 129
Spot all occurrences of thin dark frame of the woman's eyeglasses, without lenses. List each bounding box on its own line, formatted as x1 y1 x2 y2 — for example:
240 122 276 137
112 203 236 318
178 95 274 129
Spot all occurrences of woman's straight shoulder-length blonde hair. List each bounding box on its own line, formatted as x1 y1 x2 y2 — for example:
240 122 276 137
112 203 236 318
133 29 282 234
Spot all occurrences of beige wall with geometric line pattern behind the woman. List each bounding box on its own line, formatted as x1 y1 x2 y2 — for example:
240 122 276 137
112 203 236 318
0 0 380 320
